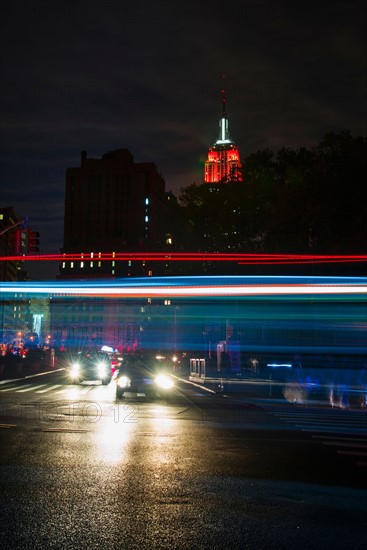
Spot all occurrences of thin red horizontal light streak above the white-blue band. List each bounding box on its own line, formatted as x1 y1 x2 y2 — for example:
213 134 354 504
0 252 367 264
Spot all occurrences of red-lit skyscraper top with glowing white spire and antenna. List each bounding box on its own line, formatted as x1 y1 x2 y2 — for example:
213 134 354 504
204 77 242 183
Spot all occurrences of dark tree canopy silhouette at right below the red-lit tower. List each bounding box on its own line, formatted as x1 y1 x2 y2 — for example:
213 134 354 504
166 131 367 254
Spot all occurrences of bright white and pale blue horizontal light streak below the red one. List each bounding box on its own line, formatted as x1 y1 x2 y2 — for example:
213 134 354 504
0 282 367 297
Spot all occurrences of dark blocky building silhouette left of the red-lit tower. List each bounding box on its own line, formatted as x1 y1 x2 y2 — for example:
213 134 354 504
60 149 165 278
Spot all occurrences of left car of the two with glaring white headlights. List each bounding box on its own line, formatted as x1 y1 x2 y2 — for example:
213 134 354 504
66 351 111 384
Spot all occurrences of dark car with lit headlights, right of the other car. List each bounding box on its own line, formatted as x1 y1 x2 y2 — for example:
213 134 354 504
114 355 174 399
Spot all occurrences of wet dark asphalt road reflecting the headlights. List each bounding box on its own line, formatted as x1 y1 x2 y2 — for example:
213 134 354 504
0 373 367 550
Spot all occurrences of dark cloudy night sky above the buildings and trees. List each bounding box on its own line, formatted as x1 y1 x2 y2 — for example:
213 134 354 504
0 0 366 268
